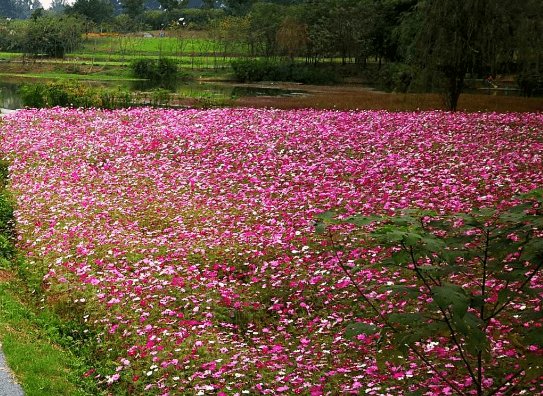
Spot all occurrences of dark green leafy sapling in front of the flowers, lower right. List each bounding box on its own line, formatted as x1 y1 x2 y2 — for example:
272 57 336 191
316 190 543 396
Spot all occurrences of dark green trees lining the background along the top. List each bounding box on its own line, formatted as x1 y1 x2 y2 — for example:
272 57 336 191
0 0 543 109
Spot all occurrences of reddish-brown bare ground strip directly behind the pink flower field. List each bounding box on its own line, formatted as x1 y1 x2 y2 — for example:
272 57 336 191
234 84 543 112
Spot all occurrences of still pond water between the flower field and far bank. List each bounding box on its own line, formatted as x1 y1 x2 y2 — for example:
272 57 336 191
0 80 308 109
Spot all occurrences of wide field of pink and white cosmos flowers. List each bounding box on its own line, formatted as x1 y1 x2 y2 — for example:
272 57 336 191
0 108 543 396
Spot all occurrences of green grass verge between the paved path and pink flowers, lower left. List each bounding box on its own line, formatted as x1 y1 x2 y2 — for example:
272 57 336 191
0 155 100 396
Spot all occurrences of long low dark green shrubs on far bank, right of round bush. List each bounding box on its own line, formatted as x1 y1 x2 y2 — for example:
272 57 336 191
231 59 338 84
